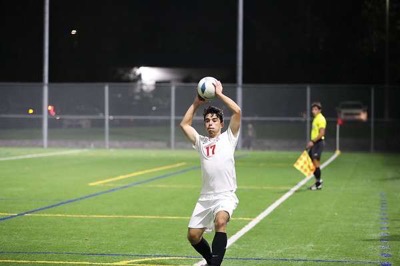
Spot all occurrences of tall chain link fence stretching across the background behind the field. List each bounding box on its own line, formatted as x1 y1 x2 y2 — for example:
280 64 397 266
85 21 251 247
0 83 400 152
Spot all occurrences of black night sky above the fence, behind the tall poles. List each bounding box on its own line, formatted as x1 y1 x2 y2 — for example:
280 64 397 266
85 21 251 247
0 0 400 84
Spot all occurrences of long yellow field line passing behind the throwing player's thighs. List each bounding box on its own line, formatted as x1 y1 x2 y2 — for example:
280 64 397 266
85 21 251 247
0 212 253 221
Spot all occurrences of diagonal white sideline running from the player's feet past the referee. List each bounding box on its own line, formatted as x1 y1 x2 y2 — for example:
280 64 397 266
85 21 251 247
193 150 340 266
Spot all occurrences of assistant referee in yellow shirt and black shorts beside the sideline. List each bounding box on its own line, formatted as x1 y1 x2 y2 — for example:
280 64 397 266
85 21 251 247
306 102 326 190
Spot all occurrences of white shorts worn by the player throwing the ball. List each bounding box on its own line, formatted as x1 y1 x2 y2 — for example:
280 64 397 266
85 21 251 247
188 192 239 231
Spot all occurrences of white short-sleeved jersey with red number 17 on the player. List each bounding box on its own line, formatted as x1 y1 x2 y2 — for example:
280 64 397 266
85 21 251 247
194 127 239 195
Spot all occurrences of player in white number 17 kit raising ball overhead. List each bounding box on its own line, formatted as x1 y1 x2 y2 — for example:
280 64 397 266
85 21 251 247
180 81 241 265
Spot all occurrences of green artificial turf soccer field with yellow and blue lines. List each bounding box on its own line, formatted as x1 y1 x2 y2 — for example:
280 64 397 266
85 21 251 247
0 148 400 265
